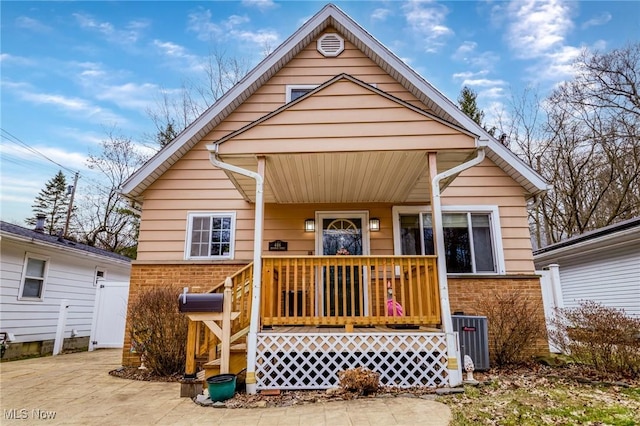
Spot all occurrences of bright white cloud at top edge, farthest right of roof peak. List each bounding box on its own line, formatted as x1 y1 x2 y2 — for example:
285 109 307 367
506 0 573 59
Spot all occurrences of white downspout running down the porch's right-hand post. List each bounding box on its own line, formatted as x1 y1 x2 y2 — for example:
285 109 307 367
431 146 485 387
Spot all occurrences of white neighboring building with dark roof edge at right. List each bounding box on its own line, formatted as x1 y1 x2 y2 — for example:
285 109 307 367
533 217 640 317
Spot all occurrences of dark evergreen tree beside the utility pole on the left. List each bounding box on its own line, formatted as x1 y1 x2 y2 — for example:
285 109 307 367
26 170 69 235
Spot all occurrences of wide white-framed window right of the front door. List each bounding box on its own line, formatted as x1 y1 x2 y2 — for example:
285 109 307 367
394 207 504 274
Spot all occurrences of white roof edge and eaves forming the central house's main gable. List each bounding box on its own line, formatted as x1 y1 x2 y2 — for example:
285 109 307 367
121 4 548 198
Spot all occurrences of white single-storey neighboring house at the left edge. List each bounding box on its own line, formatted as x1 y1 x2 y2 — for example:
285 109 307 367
0 221 131 359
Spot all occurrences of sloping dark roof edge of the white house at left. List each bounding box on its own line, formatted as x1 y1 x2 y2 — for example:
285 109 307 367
0 221 131 263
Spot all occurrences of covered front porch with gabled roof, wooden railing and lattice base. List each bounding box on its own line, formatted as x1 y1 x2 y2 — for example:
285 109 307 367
188 74 484 392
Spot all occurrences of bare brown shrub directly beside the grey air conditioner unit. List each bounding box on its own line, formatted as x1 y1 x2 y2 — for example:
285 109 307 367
485 291 545 366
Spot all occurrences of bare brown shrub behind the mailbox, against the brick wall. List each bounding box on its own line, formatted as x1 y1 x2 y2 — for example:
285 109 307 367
129 286 188 376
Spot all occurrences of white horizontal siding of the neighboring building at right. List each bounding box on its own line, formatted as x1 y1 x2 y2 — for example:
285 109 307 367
559 245 640 316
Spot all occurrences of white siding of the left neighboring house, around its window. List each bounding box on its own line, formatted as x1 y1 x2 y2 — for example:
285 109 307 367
0 238 131 342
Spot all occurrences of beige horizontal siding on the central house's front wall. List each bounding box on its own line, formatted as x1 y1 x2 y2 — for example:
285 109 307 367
132 30 533 273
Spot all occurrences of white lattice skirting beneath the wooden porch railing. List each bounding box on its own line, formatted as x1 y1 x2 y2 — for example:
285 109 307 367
256 333 448 389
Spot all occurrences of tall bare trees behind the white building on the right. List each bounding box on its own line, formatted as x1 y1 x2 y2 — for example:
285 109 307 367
542 44 640 242
